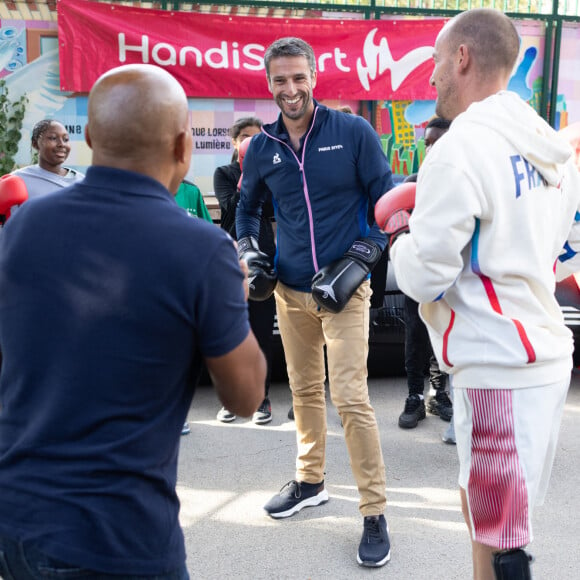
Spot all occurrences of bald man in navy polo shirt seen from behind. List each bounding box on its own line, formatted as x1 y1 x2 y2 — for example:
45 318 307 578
0 65 266 580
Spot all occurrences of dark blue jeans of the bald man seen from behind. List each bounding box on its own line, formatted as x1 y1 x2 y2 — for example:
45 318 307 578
0 536 189 580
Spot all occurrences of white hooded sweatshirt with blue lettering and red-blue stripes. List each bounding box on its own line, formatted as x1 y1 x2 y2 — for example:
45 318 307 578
391 91 580 389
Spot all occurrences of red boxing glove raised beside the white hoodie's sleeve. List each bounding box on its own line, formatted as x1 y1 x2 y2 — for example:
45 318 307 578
375 182 417 247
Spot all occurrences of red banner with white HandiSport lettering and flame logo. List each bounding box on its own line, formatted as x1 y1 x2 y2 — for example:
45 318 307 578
58 0 444 100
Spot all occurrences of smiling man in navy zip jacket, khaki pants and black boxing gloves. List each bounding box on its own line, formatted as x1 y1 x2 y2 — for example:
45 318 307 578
236 38 393 566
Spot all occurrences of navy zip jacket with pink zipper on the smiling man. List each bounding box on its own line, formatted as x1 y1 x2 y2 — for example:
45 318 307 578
236 101 393 292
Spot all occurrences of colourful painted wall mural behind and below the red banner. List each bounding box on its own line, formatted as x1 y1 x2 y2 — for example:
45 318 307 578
0 13 580 195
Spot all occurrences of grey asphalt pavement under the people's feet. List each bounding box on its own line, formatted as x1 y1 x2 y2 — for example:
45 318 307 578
178 375 580 580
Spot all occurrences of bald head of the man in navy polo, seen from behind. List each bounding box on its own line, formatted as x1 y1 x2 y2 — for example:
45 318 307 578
86 64 191 186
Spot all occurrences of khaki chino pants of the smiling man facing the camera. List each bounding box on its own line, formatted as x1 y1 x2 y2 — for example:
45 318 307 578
276 280 386 516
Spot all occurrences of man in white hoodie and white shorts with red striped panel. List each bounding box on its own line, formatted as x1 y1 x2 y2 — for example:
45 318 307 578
391 9 580 580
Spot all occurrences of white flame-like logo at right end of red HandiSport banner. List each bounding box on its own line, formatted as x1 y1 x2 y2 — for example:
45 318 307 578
356 28 433 91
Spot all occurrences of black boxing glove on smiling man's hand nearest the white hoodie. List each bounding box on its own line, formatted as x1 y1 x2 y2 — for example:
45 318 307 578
312 239 382 314
